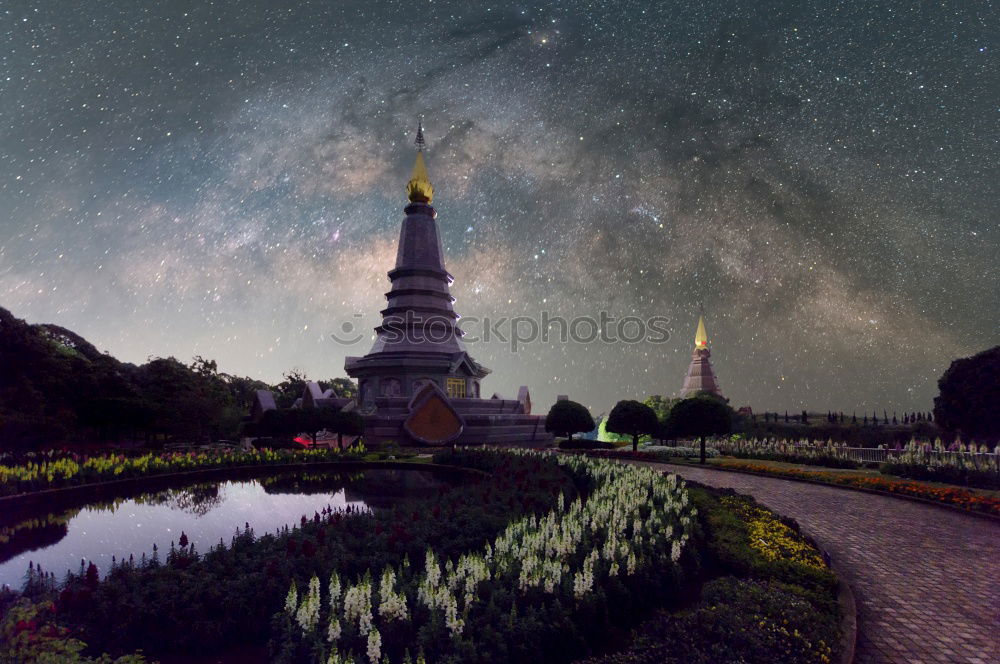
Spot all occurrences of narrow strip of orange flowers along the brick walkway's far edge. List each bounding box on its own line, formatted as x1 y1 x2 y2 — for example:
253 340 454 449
720 462 1000 516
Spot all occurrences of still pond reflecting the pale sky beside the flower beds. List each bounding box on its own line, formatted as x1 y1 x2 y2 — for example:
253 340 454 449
0 470 444 589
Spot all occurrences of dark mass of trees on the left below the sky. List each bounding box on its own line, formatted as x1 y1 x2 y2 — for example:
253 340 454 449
0 308 274 451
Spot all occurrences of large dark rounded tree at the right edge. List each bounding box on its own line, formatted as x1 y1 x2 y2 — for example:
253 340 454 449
934 346 1000 442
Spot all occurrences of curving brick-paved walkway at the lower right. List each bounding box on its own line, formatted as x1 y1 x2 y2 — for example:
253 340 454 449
657 464 1000 664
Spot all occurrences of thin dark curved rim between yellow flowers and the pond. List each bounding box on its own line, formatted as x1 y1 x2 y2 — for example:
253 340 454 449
0 461 488 511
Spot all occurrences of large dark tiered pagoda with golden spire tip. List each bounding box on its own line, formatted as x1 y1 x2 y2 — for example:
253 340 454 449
337 127 552 446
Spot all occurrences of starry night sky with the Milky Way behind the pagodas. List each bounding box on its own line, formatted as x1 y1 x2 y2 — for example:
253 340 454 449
0 0 1000 415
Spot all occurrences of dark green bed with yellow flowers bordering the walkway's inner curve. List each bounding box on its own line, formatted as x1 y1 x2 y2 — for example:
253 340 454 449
582 487 841 664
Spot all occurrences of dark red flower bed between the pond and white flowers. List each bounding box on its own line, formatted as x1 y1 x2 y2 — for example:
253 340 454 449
9 452 584 659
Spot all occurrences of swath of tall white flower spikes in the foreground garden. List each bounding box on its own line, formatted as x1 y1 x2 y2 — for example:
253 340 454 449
286 450 696 664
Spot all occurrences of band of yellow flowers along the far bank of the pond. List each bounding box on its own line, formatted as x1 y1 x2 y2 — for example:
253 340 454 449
0 445 376 496
